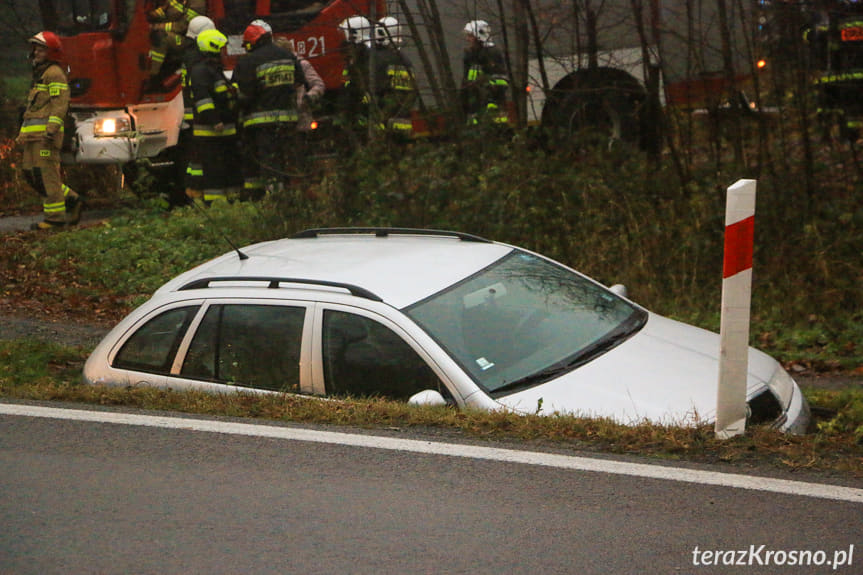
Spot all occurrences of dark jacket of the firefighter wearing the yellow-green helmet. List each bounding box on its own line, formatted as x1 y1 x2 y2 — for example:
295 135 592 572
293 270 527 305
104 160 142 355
191 57 237 138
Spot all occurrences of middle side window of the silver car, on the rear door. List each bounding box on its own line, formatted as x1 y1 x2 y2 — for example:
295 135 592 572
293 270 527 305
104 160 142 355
180 304 306 391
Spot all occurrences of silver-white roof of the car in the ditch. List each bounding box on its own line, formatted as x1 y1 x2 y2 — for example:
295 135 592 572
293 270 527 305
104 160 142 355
156 228 514 308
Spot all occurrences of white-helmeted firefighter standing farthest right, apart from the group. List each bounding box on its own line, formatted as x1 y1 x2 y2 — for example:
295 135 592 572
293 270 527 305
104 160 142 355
461 20 509 124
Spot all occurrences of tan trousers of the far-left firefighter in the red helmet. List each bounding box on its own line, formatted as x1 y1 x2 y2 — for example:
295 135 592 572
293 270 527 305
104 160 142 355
22 140 78 224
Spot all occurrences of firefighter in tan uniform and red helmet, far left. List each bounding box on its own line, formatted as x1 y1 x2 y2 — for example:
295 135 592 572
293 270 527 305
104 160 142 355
17 31 83 230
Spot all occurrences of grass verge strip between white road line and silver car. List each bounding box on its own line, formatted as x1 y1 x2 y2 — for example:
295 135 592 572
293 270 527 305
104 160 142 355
0 340 863 478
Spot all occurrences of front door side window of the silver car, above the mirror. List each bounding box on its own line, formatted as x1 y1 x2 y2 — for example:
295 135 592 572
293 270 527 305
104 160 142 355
322 310 444 400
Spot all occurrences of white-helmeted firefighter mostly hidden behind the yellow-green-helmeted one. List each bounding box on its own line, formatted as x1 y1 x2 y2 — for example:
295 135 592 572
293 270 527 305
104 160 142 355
181 16 216 204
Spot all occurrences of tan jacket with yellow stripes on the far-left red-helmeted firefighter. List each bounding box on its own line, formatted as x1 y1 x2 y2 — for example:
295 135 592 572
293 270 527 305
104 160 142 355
18 61 69 149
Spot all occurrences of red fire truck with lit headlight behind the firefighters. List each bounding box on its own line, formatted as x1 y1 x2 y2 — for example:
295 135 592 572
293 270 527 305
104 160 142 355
39 0 385 164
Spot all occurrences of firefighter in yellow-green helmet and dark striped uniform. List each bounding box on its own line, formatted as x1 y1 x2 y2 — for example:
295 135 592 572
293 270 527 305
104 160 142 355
190 30 243 205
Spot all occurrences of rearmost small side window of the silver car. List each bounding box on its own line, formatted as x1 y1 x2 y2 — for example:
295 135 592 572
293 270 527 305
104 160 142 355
113 305 199 374
